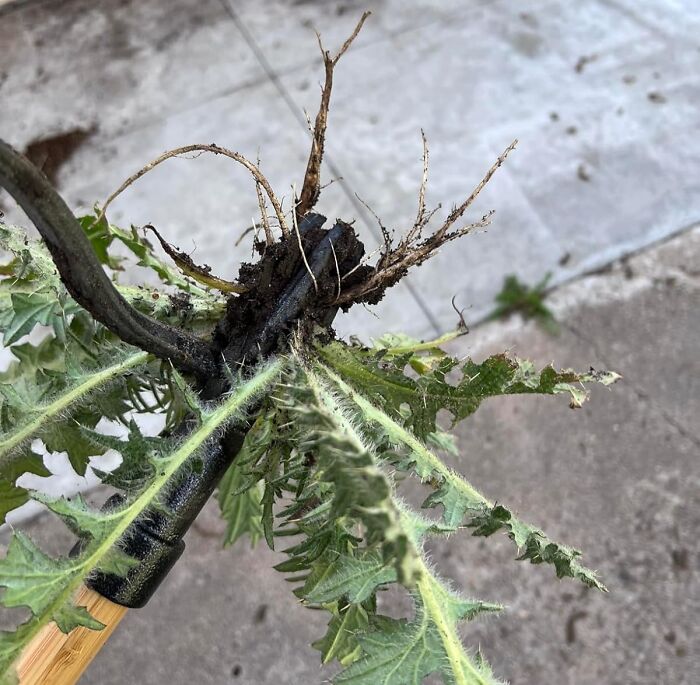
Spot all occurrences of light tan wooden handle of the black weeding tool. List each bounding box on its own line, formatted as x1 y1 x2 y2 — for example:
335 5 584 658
16 585 128 685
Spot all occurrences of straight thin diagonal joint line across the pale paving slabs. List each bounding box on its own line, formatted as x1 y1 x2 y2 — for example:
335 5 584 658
221 0 442 335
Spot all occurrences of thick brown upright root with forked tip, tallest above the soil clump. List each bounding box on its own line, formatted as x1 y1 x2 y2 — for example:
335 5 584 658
296 12 371 220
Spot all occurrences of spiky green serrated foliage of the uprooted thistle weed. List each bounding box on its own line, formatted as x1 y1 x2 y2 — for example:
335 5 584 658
0 204 617 685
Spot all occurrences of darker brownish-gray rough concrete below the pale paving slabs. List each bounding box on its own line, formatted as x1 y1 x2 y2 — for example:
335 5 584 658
2 229 700 685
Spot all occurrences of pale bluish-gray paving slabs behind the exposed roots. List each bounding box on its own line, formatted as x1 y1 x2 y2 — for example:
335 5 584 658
0 0 700 335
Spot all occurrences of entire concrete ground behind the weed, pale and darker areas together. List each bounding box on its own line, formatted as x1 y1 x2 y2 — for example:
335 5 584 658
0 0 700 685
